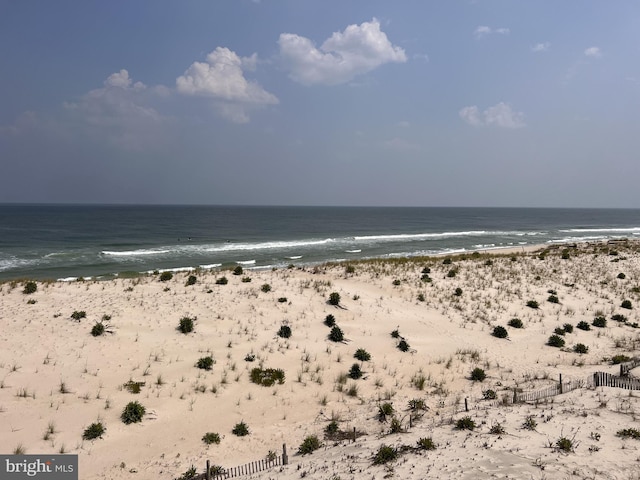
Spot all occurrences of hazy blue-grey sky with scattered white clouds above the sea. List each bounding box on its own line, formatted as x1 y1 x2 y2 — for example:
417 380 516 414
0 0 640 208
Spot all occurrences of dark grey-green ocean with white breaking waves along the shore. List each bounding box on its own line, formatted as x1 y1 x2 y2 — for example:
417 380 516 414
0 205 640 280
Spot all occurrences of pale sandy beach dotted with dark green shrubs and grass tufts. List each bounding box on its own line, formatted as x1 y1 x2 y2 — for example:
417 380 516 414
0 241 640 480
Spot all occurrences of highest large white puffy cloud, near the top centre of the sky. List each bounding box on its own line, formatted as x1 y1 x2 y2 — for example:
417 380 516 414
278 18 407 85
